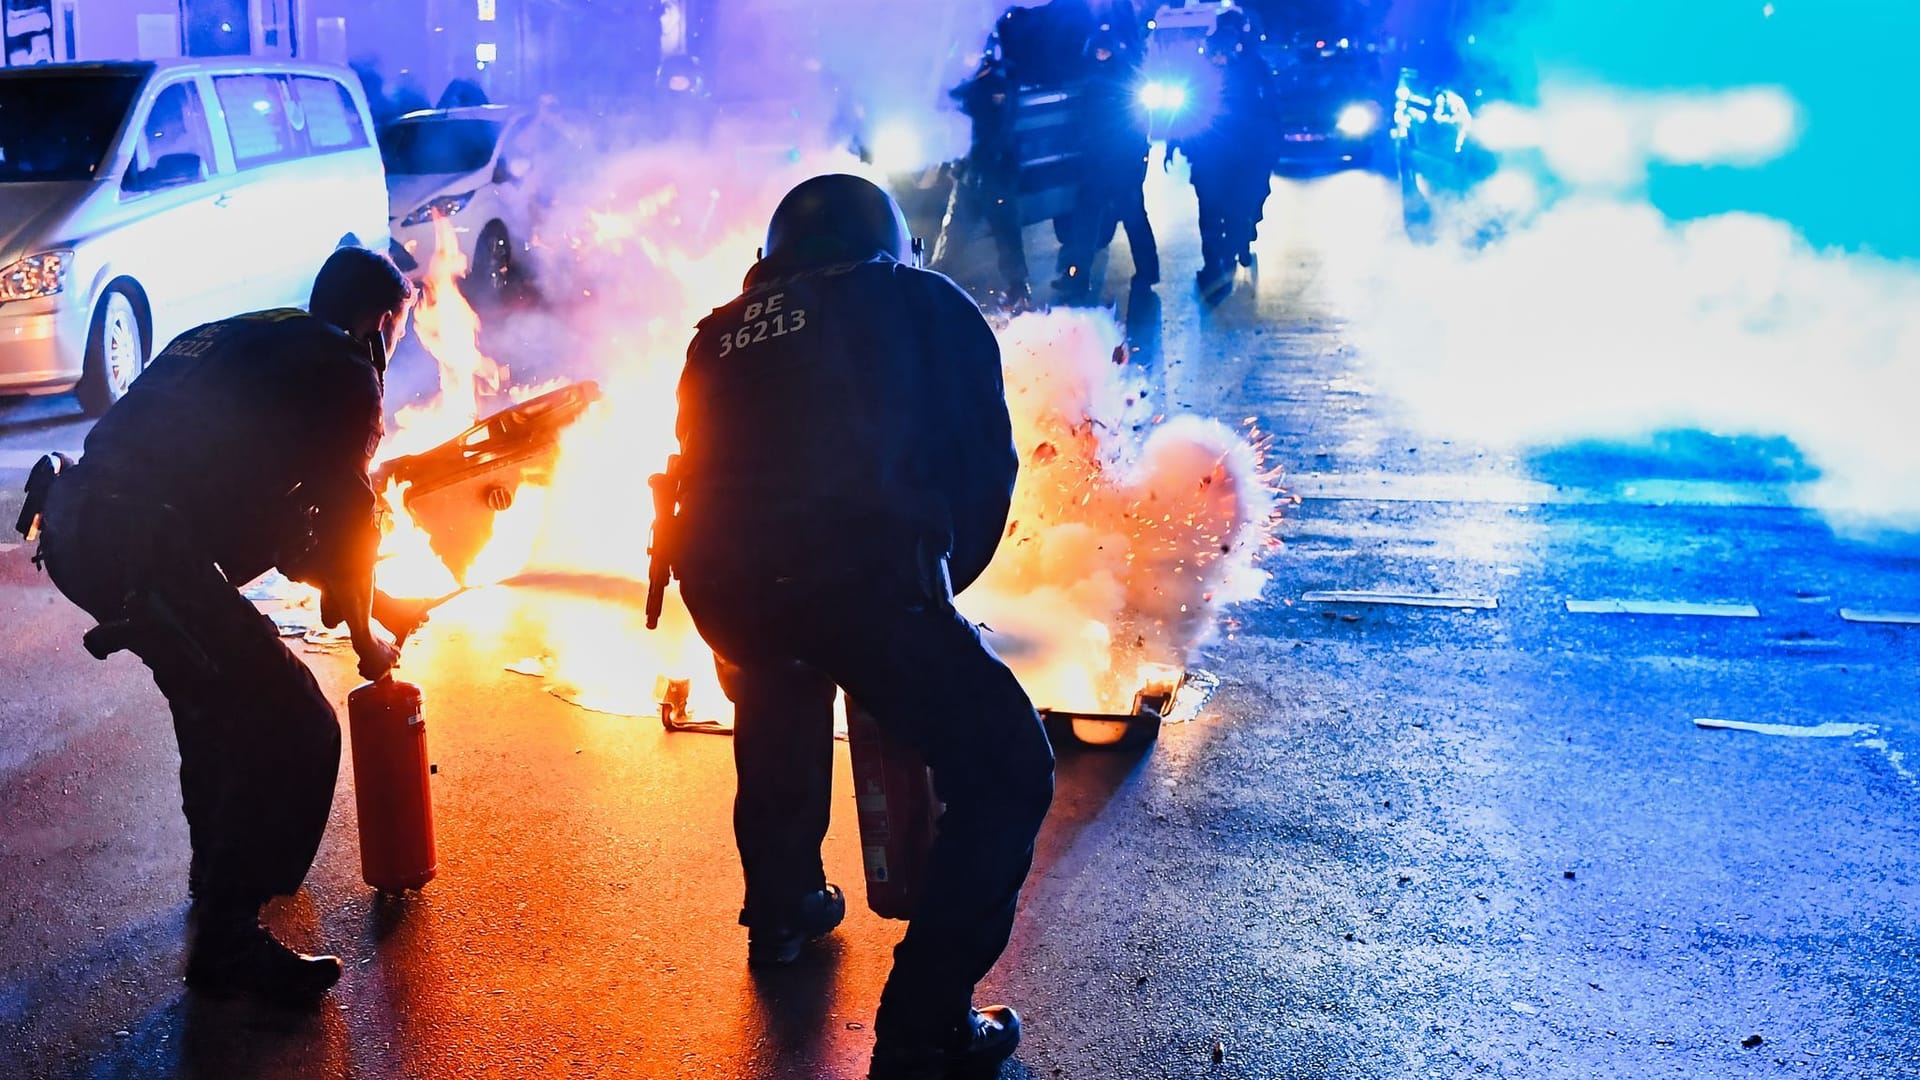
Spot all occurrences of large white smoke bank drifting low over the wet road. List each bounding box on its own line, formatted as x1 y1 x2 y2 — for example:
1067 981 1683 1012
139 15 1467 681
1354 200 1920 527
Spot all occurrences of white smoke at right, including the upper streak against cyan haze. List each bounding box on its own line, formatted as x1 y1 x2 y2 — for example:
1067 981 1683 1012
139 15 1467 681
1334 71 1920 530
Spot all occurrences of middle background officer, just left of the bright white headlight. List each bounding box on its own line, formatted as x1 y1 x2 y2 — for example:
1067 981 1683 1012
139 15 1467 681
1054 25 1160 304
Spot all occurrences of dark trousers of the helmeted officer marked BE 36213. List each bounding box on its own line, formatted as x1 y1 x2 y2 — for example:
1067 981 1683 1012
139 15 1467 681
682 575 1054 1038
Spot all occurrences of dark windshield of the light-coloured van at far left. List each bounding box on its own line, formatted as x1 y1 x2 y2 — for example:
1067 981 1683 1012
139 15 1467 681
0 73 144 184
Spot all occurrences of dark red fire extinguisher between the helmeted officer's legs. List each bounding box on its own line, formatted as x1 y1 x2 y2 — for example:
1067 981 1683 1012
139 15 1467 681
847 698 941 919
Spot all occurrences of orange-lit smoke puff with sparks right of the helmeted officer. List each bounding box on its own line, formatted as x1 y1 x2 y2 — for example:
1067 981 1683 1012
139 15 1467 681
962 311 1275 711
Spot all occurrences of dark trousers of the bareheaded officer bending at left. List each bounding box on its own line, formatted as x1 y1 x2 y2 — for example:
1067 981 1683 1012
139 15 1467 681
40 463 340 907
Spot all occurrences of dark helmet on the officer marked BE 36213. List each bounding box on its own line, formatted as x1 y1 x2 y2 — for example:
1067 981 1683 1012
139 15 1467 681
762 173 914 269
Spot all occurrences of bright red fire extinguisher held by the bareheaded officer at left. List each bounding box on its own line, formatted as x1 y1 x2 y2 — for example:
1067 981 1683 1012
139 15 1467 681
348 675 440 892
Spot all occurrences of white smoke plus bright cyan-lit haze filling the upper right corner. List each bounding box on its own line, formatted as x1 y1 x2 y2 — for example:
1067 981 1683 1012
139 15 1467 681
1340 2 1920 532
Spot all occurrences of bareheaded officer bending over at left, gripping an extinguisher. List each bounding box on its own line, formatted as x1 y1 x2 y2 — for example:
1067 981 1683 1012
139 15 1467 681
40 248 413 1001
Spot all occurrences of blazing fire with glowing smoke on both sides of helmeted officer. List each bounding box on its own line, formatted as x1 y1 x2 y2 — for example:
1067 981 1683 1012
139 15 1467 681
380 152 1273 717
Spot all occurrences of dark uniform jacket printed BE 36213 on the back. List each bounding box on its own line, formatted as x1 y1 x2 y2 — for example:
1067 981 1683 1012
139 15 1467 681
676 256 1018 588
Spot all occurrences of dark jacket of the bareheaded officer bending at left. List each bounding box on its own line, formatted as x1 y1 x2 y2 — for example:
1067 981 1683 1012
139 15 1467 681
81 309 382 582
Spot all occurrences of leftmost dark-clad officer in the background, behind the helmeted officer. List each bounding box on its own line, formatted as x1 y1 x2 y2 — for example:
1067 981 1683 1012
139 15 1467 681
933 47 1033 307
